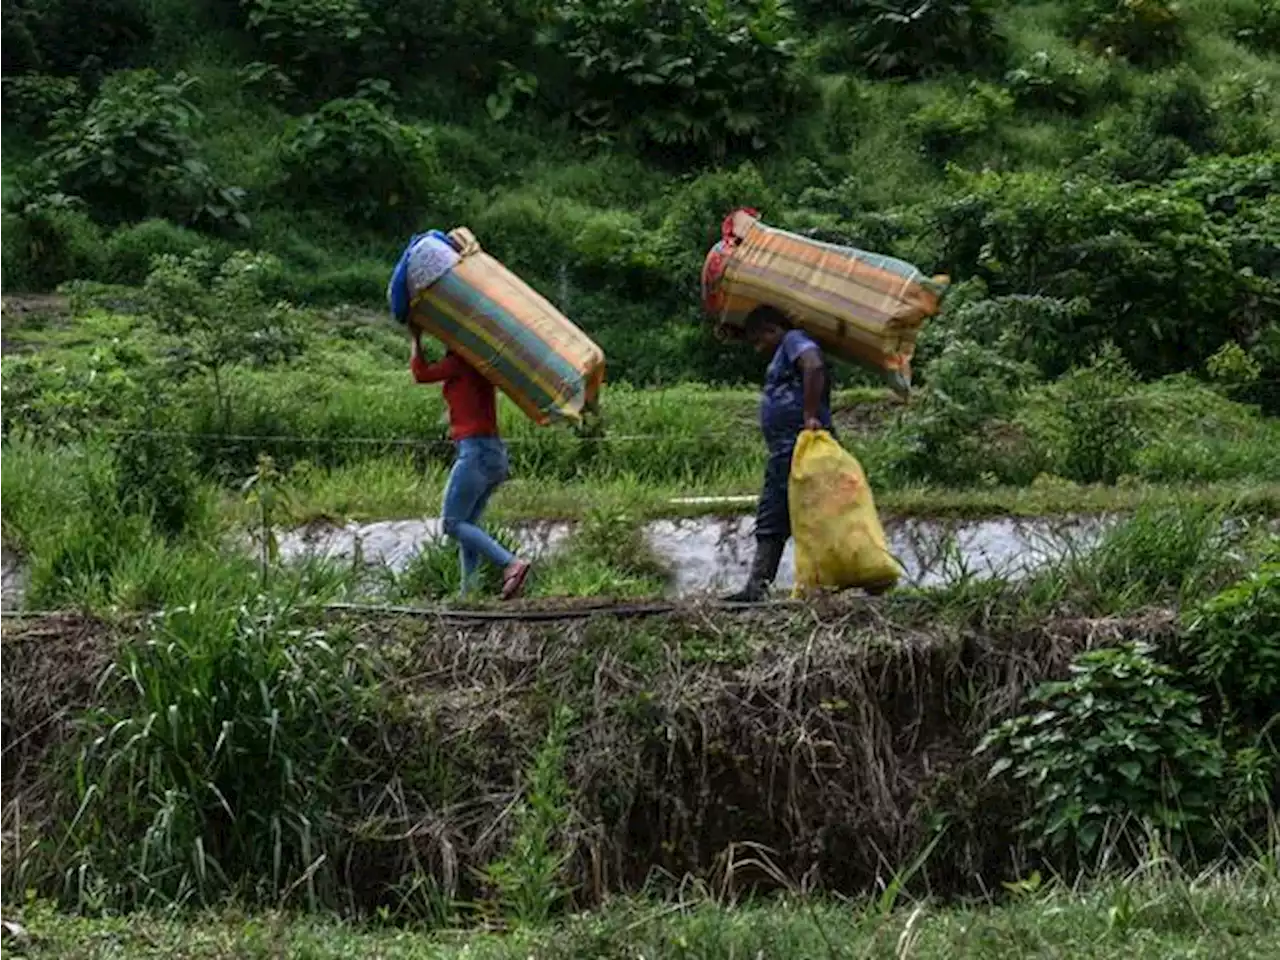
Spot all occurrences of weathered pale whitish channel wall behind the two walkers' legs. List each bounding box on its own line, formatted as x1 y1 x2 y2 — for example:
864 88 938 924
280 517 1110 596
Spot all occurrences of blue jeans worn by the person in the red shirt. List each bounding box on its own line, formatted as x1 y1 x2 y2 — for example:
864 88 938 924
443 436 516 593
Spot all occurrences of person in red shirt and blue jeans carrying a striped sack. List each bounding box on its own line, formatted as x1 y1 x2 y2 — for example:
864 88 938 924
410 332 530 600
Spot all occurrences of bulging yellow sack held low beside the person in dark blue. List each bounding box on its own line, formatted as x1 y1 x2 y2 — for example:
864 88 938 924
788 430 902 596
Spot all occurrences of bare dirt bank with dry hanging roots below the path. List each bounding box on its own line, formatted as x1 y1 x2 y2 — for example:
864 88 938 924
0 602 1174 905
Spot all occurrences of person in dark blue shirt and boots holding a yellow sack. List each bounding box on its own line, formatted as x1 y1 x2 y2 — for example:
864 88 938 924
727 307 833 603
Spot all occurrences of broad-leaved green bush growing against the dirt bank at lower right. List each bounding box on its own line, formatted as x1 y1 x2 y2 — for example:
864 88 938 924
979 644 1226 858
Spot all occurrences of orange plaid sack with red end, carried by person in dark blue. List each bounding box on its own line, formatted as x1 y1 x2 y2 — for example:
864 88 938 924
703 210 948 394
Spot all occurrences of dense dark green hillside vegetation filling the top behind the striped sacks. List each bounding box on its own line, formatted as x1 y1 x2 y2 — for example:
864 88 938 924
0 0 1280 386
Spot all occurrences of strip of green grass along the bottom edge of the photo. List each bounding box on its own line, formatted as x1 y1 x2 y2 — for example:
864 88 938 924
12 874 1280 960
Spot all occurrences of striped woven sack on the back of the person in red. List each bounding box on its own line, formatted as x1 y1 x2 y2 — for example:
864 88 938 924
410 228 604 426
